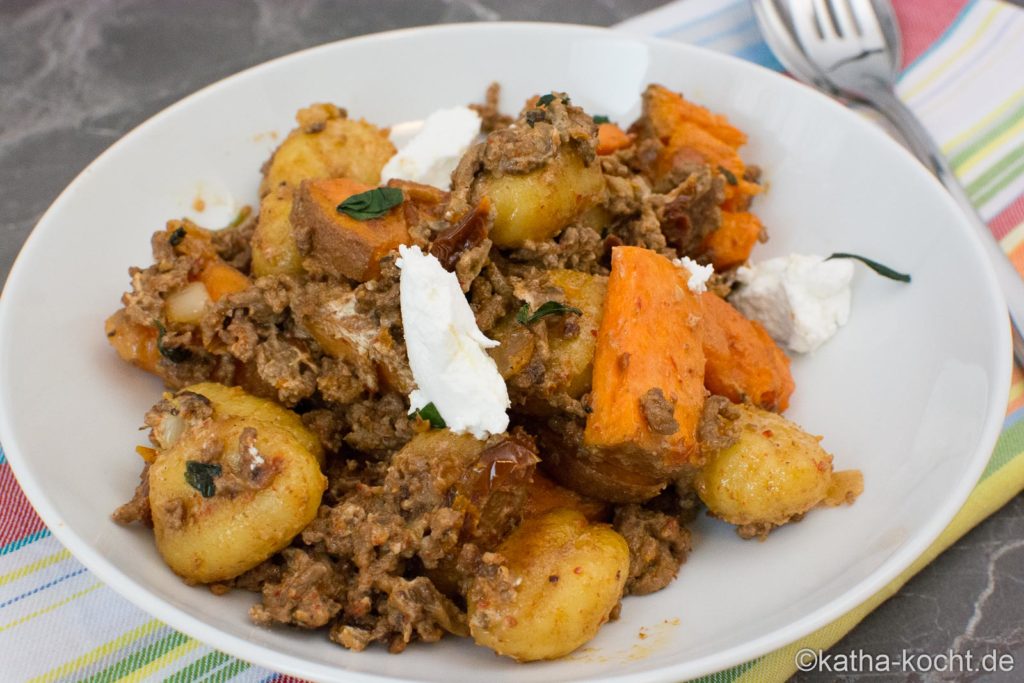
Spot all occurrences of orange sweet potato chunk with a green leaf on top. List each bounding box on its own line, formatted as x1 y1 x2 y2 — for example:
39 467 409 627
292 178 410 282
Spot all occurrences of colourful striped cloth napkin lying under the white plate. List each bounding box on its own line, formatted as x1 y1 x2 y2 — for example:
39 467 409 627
0 0 1024 683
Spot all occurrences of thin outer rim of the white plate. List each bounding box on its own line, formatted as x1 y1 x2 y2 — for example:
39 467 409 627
0 22 1012 683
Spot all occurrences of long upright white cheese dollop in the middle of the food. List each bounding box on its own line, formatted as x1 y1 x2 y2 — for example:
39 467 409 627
397 246 510 439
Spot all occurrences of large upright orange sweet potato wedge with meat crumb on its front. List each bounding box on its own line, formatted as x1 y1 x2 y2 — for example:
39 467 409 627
584 247 705 476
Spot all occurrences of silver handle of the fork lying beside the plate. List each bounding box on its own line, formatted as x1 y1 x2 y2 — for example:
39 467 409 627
868 88 1024 366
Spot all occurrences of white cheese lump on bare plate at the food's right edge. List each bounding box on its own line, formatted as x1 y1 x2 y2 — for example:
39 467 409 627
729 254 853 353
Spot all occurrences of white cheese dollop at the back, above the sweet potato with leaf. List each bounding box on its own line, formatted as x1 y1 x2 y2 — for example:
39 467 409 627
381 106 480 189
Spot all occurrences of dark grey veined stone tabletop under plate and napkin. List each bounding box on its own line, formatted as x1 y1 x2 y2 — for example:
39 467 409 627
0 0 1024 681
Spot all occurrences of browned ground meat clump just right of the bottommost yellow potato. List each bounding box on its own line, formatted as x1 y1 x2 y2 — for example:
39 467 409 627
612 505 690 595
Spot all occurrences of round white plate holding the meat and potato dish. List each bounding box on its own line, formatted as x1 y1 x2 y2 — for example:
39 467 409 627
0 24 1010 683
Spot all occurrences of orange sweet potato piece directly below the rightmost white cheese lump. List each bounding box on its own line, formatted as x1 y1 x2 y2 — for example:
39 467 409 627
700 292 796 413
